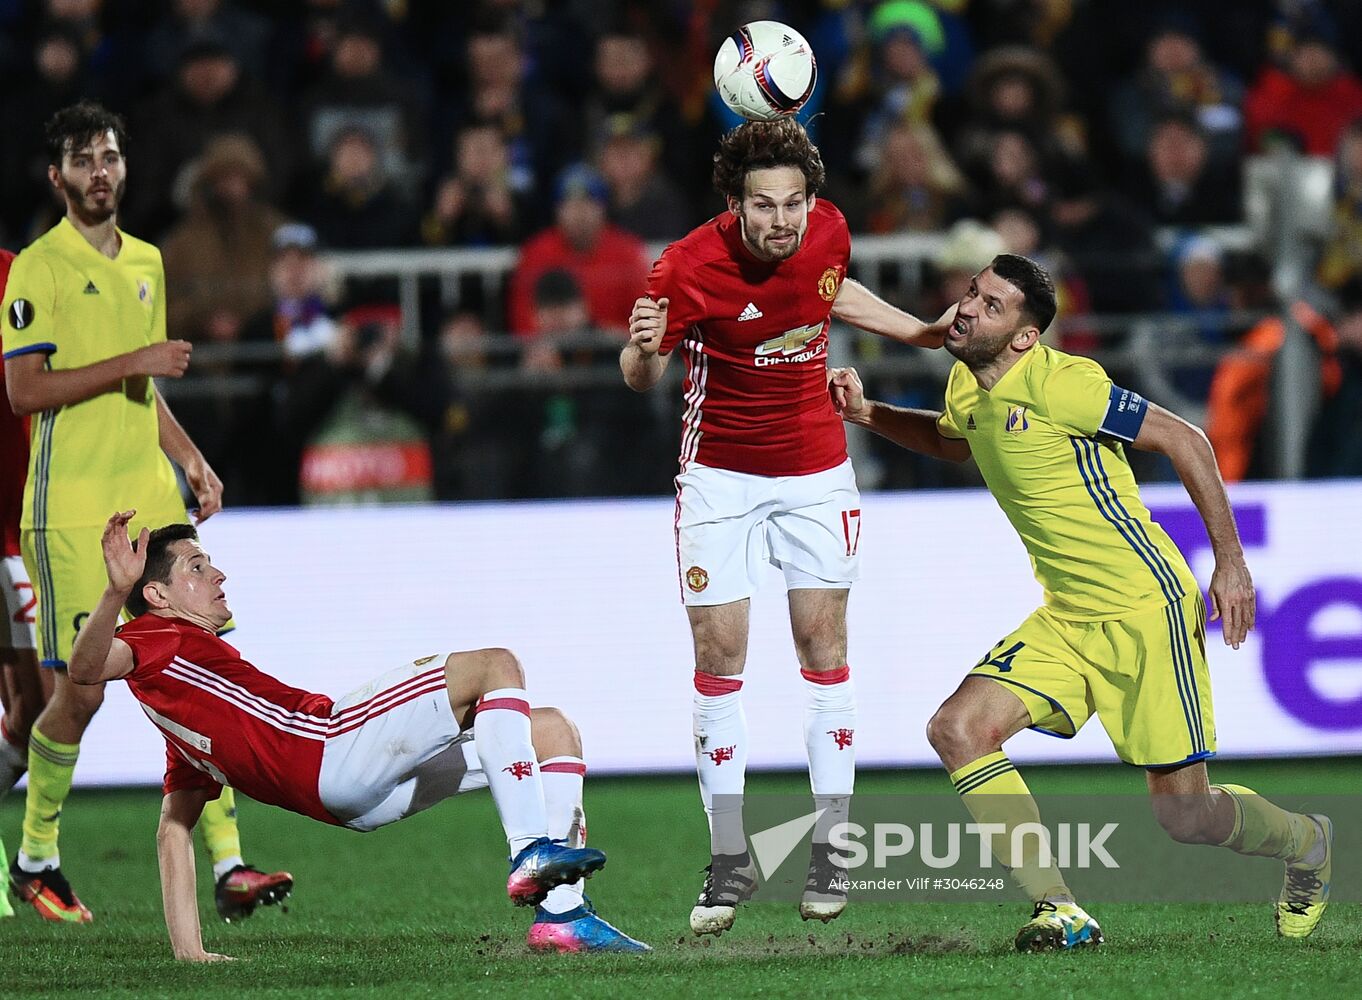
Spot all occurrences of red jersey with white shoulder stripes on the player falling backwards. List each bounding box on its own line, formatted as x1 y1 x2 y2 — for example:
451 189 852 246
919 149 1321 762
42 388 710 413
117 614 336 823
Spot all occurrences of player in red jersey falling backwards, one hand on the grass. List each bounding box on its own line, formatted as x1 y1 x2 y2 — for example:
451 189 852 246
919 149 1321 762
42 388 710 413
69 511 650 960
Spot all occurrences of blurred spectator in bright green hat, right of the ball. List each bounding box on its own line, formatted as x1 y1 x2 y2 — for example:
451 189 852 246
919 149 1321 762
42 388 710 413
825 0 945 173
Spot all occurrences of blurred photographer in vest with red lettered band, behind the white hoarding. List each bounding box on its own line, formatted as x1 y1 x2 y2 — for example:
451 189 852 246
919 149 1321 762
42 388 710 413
282 307 434 505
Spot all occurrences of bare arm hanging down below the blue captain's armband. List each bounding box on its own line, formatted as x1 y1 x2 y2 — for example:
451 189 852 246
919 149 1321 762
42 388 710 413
1135 403 1257 649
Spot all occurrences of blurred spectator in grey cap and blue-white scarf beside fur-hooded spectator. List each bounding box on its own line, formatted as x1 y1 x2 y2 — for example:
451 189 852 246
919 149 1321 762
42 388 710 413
242 222 336 361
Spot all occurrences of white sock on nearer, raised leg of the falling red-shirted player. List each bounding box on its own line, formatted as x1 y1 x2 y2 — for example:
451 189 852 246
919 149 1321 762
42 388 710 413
473 688 549 858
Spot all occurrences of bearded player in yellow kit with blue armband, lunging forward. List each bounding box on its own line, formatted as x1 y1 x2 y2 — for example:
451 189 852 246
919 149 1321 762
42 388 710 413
831 253 1333 951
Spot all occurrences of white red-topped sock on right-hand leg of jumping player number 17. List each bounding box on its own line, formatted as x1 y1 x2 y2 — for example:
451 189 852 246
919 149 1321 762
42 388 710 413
799 666 855 843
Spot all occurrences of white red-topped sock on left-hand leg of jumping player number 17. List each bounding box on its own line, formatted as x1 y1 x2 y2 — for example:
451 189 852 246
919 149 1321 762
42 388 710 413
692 670 748 854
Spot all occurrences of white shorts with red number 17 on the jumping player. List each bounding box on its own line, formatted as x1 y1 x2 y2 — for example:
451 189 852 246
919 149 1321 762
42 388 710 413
676 459 861 606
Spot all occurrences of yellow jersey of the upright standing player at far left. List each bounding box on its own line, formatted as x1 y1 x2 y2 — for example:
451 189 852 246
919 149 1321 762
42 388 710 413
4 218 184 531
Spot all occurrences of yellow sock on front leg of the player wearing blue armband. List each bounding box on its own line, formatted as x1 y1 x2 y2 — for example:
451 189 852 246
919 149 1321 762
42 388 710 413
951 751 1073 902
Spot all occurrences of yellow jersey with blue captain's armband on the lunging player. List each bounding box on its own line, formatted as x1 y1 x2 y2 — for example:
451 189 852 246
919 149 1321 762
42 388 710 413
937 345 1197 621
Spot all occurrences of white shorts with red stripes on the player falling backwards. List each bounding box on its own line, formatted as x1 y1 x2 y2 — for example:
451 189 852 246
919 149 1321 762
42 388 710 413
317 653 488 832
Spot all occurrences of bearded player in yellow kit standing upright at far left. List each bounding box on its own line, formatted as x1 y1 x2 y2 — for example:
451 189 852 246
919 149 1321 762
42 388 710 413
0 102 293 922
